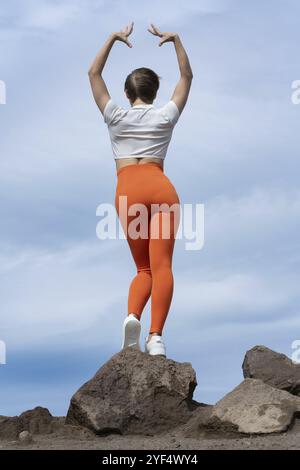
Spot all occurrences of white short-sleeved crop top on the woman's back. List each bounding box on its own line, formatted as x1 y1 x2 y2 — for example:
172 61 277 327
103 98 180 160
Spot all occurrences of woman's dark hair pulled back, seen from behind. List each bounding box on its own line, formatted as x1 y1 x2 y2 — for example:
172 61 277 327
124 67 161 103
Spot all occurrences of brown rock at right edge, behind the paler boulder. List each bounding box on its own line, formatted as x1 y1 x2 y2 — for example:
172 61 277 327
242 346 300 396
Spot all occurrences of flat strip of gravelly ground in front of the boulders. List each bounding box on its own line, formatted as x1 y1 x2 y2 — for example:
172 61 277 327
0 420 300 451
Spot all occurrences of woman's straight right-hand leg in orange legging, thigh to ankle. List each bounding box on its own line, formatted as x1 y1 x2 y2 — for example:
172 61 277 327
149 211 178 335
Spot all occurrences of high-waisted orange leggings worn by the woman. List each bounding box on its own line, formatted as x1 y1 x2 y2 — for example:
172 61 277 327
115 162 180 335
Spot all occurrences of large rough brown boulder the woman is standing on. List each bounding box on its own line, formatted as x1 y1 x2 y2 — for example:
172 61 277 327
66 347 198 435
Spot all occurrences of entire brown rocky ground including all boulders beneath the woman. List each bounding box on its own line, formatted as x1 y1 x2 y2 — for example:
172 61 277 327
0 346 300 450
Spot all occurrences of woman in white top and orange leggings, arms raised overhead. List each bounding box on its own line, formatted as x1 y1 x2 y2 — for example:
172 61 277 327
89 22 193 356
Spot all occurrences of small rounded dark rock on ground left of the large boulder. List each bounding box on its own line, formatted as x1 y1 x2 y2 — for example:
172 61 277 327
18 406 53 434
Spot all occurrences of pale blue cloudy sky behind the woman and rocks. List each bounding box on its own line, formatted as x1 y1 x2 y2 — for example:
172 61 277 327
0 0 300 415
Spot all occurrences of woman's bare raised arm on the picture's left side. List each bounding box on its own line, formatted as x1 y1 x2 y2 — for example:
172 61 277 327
88 22 133 114
